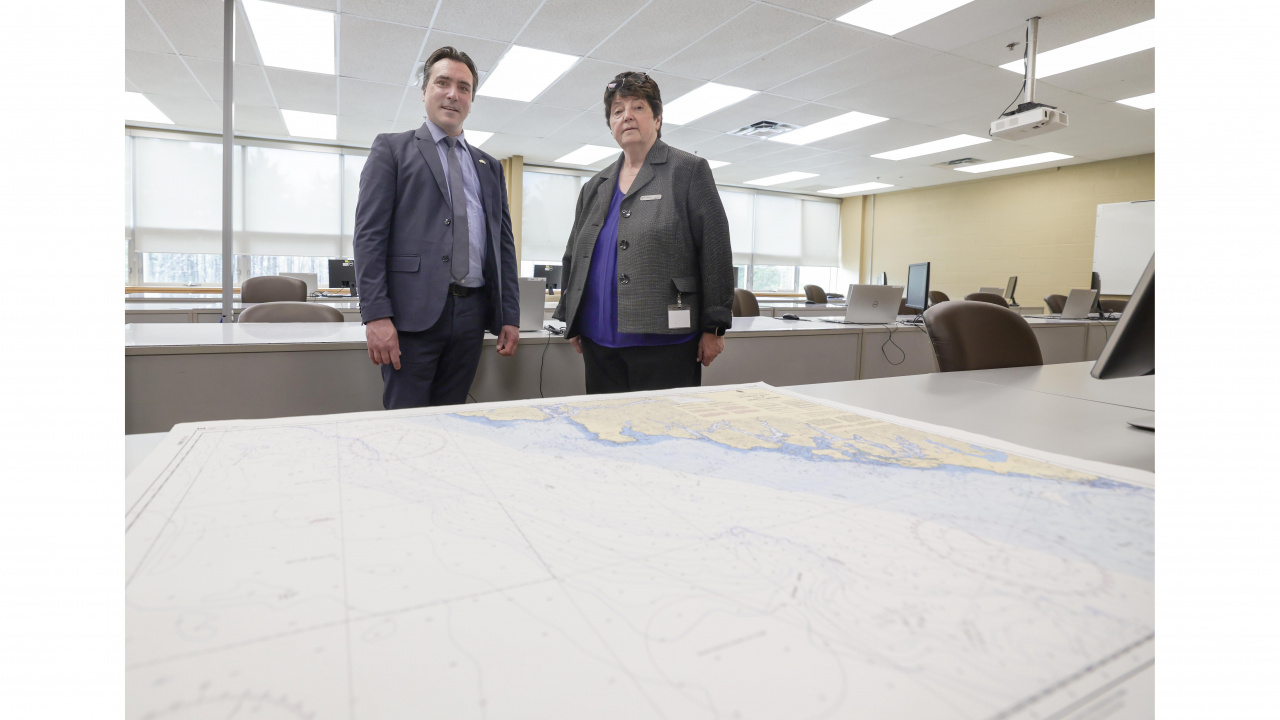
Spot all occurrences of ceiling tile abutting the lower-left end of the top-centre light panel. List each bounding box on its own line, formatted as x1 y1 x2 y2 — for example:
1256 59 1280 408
716 23 881 90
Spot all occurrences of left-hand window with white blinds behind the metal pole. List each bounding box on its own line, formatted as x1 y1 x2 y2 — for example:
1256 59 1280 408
125 137 365 287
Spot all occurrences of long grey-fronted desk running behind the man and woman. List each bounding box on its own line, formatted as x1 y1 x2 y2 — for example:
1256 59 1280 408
124 318 1102 433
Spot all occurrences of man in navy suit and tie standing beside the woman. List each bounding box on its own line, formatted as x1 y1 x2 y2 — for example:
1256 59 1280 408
353 46 520 410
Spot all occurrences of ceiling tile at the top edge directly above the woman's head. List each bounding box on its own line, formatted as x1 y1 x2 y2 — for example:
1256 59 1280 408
591 0 747 69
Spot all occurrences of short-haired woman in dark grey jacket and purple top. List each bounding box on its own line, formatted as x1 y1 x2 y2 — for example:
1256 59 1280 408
553 72 733 393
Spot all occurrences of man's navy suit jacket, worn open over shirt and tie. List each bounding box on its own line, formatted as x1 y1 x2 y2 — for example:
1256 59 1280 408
353 123 520 334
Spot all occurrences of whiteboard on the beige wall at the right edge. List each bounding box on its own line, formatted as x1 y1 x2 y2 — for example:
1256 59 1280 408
1093 200 1156 295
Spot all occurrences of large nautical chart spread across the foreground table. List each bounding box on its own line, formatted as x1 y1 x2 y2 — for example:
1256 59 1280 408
125 384 1155 719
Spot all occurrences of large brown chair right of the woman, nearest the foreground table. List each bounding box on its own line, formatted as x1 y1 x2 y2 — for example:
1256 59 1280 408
924 300 1044 373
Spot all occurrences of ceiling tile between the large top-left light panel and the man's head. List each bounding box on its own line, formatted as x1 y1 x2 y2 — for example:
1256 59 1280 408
338 17 426 86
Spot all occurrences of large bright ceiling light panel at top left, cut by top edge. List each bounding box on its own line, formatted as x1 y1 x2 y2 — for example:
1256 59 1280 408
239 0 335 76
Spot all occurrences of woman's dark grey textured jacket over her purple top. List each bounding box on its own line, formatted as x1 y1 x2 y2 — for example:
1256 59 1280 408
552 140 733 337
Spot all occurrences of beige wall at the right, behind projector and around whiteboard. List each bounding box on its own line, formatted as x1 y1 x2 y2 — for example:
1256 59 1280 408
841 154 1156 305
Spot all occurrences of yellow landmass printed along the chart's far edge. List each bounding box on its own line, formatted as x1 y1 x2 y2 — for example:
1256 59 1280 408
460 388 1096 482
